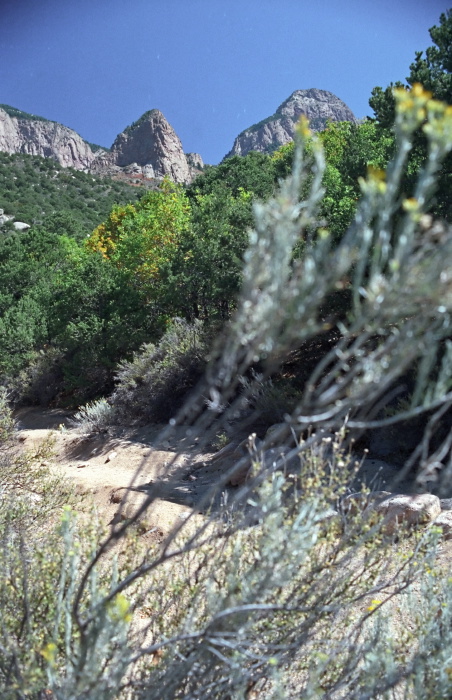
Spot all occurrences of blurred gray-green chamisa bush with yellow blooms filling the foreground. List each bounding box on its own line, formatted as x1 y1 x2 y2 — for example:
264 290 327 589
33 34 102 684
0 85 452 700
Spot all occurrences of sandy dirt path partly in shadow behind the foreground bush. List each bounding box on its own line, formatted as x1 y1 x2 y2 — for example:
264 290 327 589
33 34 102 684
15 408 233 535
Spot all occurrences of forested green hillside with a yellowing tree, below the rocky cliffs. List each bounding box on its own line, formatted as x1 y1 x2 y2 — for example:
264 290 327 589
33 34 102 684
0 127 393 405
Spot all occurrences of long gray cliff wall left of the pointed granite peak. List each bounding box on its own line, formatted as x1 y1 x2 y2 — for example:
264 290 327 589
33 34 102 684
0 108 99 170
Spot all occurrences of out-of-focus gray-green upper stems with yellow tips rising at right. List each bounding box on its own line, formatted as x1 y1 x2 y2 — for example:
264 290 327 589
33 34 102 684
178 86 452 464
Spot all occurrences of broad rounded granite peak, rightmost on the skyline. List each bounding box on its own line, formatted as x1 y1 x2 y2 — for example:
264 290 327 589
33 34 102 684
226 88 357 158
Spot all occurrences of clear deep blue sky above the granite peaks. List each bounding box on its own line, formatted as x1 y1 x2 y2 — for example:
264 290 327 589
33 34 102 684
0 0 452 164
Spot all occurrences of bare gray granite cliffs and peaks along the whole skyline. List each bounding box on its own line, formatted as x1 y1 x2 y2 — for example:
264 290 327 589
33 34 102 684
0 89 356 184
